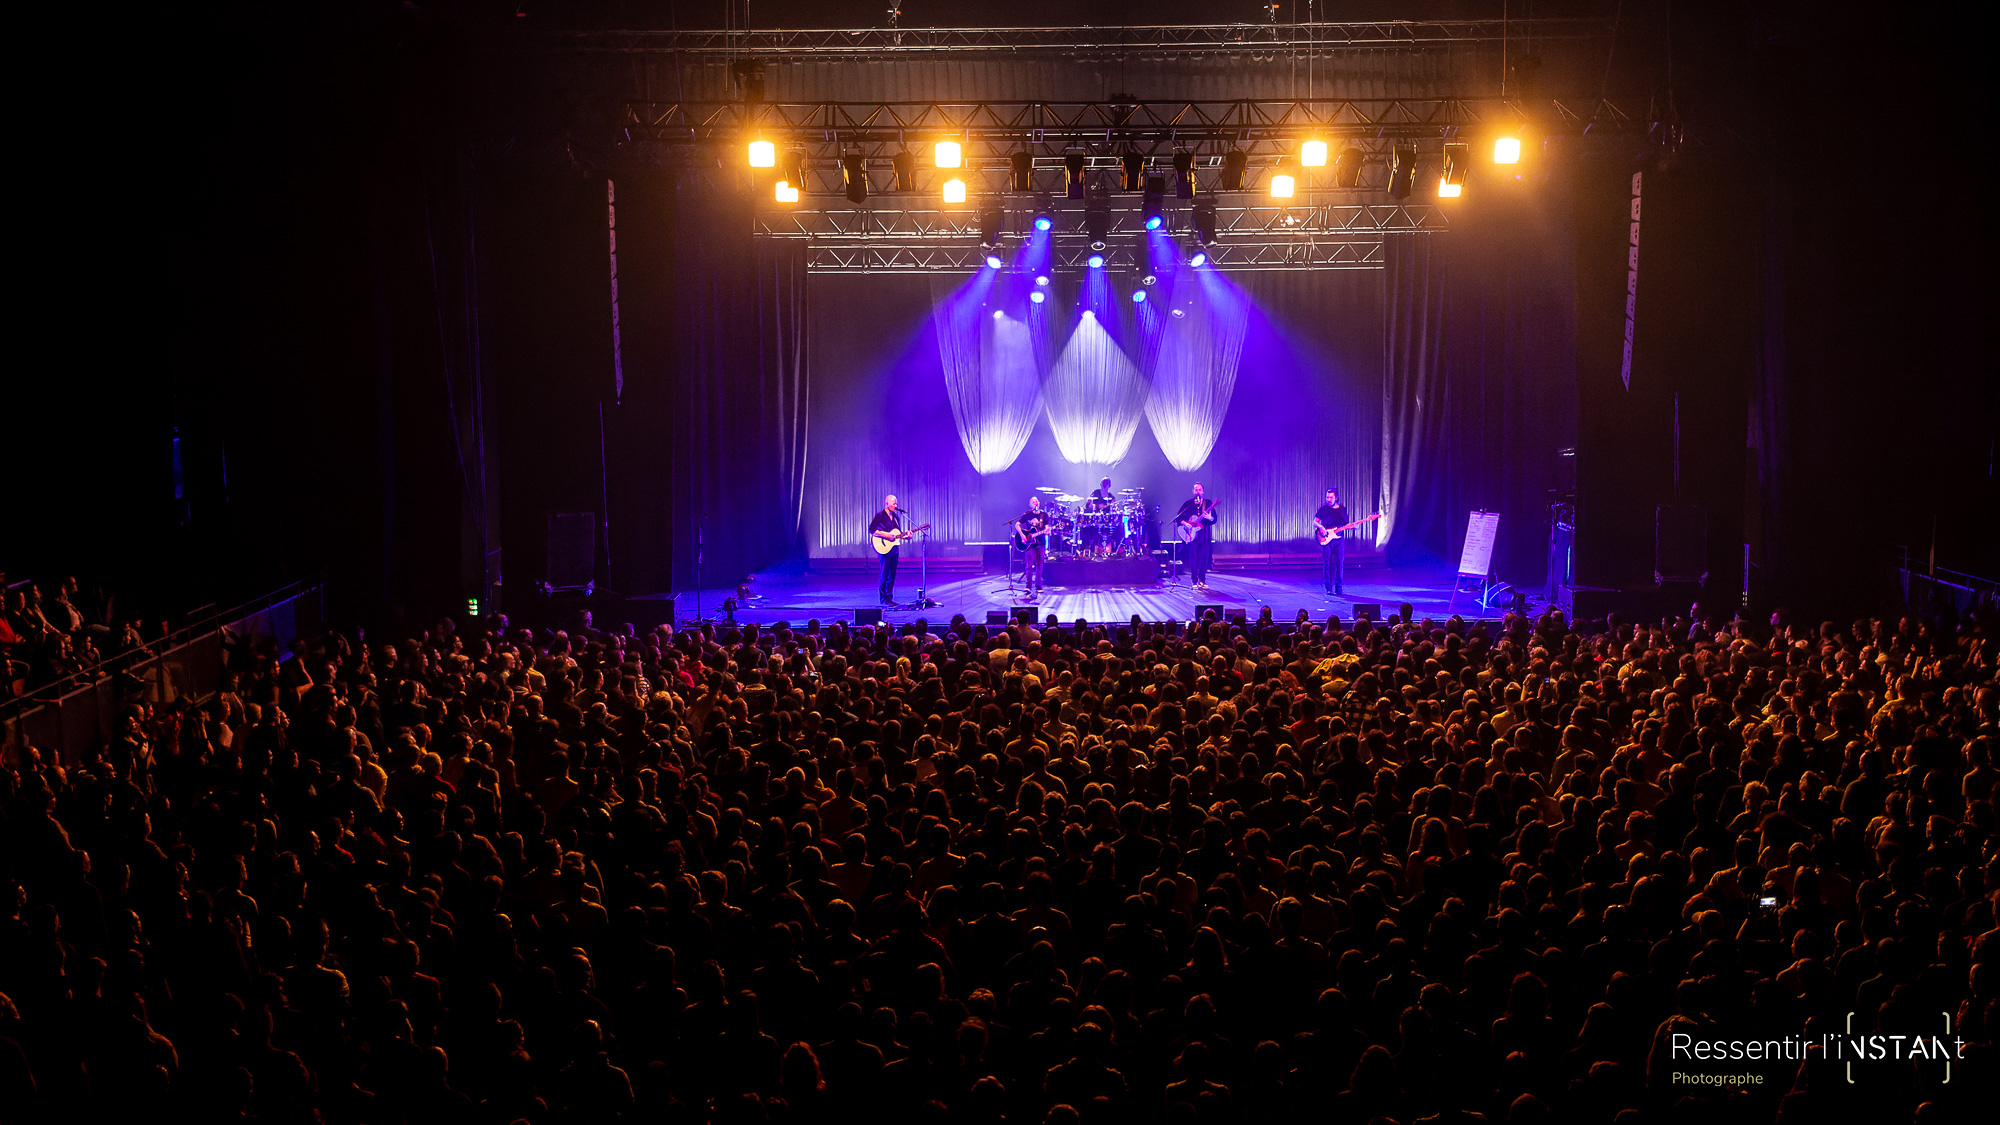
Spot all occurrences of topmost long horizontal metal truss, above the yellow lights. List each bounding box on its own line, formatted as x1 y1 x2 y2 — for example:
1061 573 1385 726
554 18 1610 58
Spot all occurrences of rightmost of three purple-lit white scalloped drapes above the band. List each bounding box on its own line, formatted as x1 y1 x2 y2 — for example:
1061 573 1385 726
1146 272 1250 472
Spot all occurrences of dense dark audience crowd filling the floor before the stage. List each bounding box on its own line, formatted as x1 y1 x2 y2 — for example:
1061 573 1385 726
0 607 2000 1125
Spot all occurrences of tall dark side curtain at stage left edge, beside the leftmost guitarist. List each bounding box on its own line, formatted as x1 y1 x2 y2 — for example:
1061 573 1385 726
606 176 810 595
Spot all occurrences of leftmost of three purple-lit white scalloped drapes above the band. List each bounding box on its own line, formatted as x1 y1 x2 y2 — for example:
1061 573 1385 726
932 270 1042 474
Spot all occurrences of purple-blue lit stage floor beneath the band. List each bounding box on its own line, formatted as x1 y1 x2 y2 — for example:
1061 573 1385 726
676 563 1502 627
